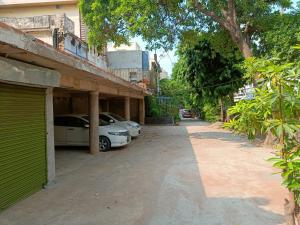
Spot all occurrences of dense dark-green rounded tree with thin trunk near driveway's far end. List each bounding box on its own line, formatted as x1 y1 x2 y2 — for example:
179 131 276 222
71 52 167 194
173 37 244 120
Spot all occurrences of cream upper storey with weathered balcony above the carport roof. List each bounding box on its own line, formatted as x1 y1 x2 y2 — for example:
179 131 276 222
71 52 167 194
0 0 107 69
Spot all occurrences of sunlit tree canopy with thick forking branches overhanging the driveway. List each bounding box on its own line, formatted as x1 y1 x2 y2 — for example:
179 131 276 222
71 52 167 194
79 0 291 58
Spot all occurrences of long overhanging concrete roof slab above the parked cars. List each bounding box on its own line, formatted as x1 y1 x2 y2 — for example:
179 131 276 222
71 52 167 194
0 23 147 98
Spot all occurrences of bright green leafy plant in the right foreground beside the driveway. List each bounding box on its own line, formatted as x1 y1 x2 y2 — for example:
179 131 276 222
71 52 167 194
225 55 300 204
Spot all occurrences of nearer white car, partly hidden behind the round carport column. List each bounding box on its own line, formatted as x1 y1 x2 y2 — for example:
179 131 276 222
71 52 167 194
54 115 131 151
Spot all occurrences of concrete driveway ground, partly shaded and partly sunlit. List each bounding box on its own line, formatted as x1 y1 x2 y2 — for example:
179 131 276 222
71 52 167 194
0 121 287 225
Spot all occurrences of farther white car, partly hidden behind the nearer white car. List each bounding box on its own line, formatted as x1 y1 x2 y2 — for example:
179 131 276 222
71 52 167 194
99 112 141 137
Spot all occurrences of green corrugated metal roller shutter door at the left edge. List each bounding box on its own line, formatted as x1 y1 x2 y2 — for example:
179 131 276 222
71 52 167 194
0 83 47 211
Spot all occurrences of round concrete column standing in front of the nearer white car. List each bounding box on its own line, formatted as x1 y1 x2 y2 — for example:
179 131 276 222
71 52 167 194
89 91 99 154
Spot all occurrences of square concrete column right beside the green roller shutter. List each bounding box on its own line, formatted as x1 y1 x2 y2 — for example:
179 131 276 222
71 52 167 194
46 88 55 186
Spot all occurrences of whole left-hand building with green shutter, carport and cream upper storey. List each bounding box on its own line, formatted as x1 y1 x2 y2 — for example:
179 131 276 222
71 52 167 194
0 0 147 211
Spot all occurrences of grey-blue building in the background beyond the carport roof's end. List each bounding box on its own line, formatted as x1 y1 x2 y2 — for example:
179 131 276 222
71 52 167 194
107 42 150 84
